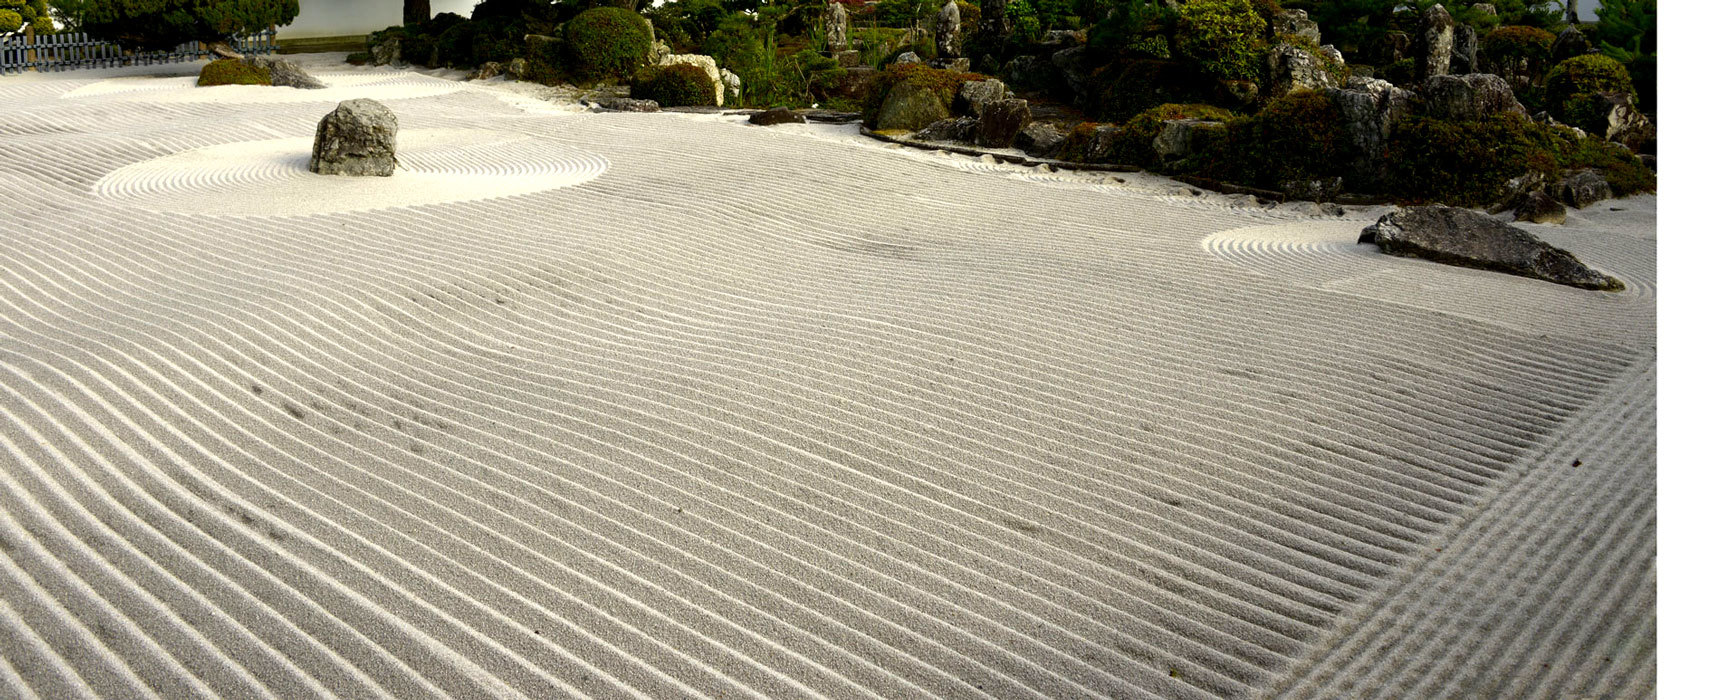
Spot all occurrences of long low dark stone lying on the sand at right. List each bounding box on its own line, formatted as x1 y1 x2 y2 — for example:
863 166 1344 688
1360 204 1623 291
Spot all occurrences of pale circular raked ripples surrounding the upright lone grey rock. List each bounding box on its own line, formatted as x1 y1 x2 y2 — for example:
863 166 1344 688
95 130 608 217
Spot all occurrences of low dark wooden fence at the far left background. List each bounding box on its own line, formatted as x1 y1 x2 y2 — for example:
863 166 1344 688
0 29 277 75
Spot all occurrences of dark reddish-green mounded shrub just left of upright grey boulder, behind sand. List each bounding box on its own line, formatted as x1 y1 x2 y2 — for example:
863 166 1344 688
1202 90 1349 189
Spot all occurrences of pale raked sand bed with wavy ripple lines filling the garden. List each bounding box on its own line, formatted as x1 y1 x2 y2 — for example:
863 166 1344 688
0 55 1656 698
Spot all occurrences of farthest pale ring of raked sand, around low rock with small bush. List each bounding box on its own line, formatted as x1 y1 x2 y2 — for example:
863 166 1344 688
61 73 462 102
